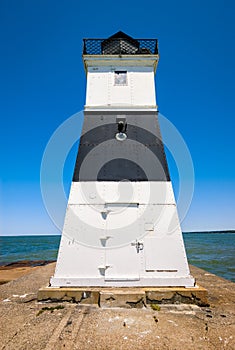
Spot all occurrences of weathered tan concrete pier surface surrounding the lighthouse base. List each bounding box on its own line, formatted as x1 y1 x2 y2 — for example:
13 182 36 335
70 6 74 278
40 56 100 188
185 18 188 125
0 263 235 350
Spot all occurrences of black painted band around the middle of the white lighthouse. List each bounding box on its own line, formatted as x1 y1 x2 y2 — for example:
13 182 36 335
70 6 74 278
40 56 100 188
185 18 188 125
73 111 170 182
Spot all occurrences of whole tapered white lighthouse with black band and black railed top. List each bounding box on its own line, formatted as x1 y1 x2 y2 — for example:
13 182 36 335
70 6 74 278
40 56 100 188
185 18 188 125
50 32 194 287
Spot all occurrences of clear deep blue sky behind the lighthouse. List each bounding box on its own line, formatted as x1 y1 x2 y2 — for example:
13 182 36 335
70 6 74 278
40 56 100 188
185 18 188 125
0 0 235 235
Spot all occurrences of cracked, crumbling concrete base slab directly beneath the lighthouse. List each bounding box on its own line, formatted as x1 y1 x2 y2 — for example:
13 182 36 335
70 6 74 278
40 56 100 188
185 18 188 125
38 285 209 308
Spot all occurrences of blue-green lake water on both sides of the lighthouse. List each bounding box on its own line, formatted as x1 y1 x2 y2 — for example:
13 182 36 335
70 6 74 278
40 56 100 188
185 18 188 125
0 232 235 282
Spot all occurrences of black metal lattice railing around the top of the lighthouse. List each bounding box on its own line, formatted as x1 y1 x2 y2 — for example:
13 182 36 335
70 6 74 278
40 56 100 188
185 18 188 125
83 38 158 55
